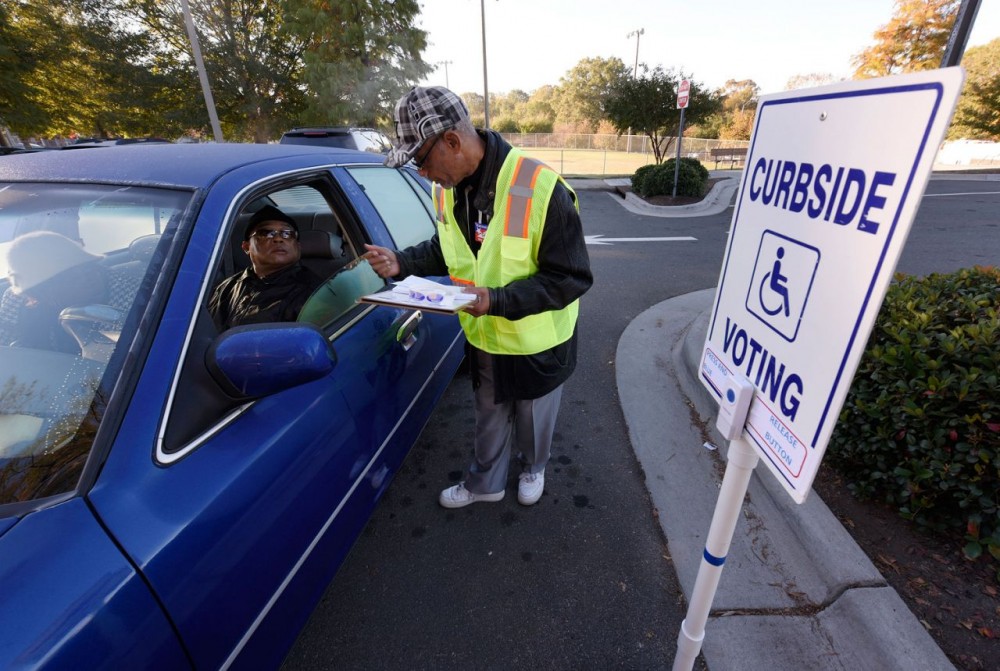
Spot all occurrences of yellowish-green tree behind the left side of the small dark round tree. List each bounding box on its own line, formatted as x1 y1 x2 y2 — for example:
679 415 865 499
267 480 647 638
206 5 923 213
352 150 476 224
553 58 632 133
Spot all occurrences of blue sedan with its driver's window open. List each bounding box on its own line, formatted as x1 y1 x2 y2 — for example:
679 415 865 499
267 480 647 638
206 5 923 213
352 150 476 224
0 144 464 669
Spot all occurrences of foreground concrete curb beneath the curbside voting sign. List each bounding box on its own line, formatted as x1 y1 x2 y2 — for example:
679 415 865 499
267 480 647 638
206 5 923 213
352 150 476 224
616 289 954 671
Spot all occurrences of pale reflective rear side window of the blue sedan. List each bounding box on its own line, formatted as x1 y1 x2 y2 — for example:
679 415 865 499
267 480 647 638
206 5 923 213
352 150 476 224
349 166 434 249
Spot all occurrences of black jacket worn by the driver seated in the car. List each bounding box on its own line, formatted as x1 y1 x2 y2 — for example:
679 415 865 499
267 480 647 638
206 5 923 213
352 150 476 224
208 263 323 331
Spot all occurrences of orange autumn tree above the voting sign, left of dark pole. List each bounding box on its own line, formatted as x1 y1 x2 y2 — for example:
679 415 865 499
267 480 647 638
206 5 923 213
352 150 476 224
853 0 961 79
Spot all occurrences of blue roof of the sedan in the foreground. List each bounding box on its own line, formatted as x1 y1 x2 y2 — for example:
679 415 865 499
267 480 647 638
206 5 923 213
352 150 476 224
0 143 383 188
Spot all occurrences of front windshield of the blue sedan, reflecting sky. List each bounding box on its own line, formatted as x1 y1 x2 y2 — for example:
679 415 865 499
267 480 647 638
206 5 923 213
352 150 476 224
0 183 192 505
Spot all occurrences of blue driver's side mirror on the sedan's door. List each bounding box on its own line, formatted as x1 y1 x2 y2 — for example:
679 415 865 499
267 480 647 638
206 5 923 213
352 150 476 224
205 323 337 399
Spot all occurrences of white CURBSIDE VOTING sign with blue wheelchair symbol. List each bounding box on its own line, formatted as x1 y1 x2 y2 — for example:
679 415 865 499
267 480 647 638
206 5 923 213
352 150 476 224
699 67 964 503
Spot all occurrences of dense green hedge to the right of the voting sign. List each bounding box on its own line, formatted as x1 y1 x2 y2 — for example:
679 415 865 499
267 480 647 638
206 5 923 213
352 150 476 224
827 267 1000 561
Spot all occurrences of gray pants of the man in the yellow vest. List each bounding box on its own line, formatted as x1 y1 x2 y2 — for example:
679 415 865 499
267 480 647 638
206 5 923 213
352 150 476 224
465 350 562 494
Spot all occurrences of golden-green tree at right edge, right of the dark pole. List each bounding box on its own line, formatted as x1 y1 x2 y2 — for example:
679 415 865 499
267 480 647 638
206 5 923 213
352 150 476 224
948 38 1000 142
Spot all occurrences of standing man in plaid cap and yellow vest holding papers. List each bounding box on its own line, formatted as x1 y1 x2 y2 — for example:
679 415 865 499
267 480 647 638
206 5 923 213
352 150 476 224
365 86 593 508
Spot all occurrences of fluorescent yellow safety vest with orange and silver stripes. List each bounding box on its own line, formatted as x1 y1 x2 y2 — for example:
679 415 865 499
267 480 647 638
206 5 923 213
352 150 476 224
433 149 580 354
